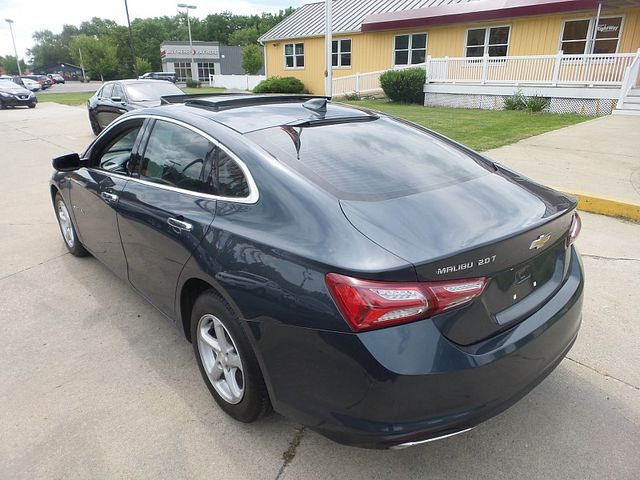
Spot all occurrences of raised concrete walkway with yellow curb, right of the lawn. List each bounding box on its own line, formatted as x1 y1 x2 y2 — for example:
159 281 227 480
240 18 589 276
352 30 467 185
485 115 640 209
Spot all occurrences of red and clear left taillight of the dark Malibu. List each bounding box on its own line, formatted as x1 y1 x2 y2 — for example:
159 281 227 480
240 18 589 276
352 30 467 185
326 273 487 332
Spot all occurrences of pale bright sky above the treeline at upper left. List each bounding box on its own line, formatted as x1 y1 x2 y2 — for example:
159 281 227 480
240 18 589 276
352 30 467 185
0 0 304 58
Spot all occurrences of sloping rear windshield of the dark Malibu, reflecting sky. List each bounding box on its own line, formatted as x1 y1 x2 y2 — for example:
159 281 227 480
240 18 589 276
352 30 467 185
246 117 489 201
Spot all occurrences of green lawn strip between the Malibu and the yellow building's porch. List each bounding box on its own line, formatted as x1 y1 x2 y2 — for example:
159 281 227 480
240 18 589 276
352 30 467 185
344 100 593 151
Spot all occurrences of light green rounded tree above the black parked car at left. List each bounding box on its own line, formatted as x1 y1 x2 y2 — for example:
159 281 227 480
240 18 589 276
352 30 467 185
69 34 118 81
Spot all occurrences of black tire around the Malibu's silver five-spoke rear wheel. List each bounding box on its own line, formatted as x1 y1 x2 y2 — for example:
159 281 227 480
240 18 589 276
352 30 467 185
191 290 271 423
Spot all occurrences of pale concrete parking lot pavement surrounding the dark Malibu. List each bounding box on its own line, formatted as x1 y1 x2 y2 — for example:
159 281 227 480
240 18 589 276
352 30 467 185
0 103 640 479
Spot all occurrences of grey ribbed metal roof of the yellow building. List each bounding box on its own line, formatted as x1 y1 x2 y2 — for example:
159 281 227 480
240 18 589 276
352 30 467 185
259 0 479 42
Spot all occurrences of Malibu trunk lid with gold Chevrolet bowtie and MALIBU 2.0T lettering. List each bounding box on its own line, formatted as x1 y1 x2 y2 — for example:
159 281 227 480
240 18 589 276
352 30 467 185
340 167 575 345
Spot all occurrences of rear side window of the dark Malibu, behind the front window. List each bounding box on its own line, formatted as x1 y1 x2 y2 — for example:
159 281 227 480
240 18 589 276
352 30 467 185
140 120 249 198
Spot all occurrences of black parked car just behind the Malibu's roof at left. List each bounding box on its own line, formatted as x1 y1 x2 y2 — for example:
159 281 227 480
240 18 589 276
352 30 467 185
87 80 183 135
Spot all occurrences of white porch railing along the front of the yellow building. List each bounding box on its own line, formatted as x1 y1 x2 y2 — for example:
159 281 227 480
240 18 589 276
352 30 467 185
333 51 640 95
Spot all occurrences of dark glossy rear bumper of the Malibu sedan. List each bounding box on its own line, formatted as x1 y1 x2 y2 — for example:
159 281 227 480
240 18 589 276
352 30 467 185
249 250 583 448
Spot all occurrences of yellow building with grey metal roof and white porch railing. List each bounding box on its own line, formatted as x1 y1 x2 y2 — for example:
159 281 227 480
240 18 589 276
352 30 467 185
260 0 640 113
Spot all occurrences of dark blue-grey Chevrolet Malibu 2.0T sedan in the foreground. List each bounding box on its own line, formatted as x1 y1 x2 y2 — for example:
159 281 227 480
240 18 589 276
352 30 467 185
51 96 583 448
